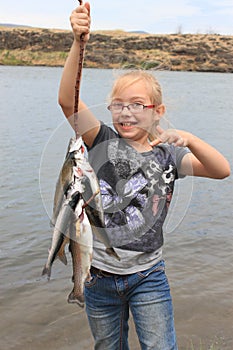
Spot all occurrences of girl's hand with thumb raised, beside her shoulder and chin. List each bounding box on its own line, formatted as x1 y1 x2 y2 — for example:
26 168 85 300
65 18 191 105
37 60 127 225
150 125 188 147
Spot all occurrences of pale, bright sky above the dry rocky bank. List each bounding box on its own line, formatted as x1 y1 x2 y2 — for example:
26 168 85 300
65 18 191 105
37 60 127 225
0 0 233 35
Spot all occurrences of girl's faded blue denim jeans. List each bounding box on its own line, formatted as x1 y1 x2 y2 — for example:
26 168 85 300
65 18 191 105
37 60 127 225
85 261 177 350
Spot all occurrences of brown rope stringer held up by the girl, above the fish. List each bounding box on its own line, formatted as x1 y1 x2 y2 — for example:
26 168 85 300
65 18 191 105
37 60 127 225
74 0 85 139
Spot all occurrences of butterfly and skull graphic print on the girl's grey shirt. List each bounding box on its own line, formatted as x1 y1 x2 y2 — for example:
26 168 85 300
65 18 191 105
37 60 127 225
95 139 176 252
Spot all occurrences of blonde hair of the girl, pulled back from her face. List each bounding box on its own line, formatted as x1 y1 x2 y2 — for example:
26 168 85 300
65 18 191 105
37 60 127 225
110 70 162 141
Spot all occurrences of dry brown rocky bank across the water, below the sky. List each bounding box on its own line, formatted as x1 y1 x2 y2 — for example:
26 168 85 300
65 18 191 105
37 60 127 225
0 27 233 73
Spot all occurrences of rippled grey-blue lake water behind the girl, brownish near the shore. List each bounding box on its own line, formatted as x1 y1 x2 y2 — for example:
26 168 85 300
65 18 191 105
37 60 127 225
0 67 233 350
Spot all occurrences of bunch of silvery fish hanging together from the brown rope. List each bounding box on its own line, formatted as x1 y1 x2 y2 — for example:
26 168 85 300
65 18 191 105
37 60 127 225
42 137 120 307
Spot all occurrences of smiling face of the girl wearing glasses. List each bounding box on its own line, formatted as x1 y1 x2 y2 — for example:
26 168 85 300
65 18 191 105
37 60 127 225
111 80 163 146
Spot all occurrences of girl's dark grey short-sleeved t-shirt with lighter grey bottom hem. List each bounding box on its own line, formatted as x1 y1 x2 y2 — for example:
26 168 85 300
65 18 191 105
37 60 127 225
88 124 189 274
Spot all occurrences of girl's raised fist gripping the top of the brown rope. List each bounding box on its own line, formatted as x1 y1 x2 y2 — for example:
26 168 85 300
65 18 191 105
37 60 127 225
70 2 91 42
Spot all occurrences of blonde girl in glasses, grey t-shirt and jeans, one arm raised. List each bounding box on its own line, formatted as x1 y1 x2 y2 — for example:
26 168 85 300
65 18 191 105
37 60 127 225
59 3 230 350
